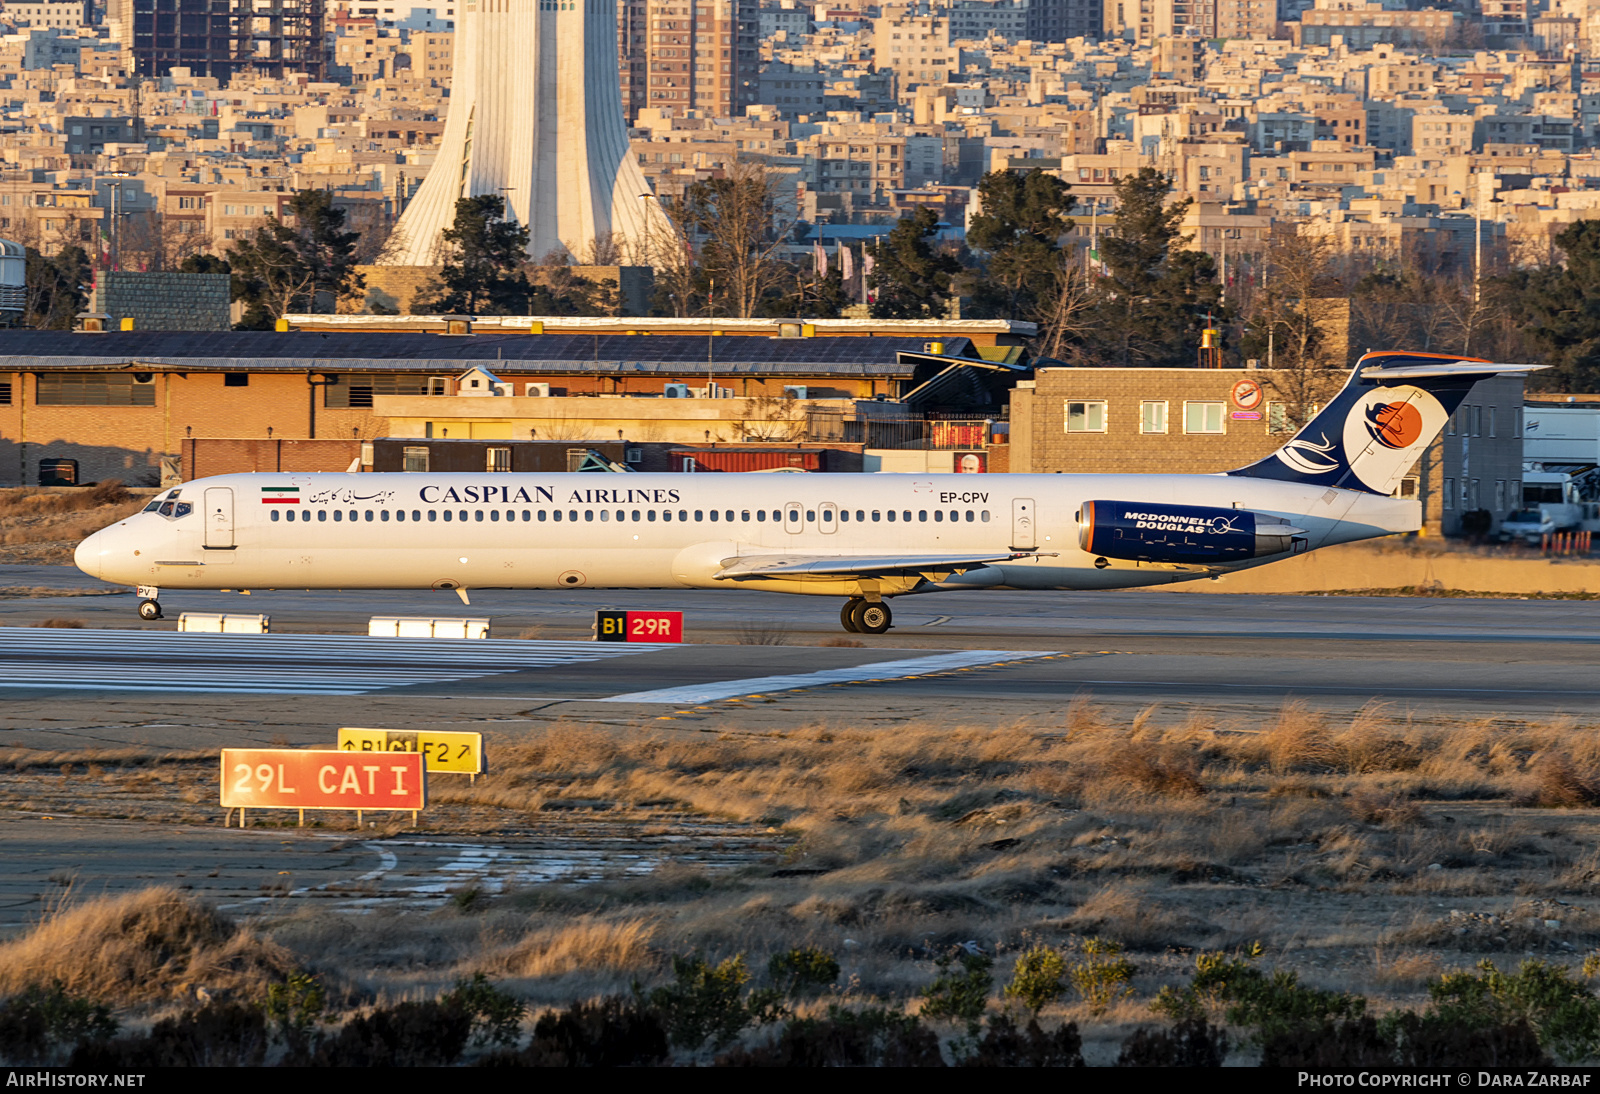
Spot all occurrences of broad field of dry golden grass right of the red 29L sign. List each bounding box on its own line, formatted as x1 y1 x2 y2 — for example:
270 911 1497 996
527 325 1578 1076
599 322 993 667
18 702 1600 1024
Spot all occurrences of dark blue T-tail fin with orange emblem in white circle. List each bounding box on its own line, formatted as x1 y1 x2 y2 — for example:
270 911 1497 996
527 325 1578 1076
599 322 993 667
1227 350 1546 494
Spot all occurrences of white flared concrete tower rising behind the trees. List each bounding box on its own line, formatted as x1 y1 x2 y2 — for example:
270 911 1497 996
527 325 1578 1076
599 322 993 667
387 0 675 266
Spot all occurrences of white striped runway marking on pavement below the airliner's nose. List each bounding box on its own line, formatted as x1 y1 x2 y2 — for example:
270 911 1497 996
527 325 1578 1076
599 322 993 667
0 627 677 696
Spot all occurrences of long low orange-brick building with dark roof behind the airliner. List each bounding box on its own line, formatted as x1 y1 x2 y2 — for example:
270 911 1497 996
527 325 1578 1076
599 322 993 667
0 326 1027 486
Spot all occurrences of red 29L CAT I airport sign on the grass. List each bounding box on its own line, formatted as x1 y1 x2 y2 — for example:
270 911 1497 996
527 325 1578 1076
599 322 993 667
222 749 427 809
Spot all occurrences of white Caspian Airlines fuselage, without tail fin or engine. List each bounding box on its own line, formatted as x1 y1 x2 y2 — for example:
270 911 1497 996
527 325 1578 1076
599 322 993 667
77 473 1421 597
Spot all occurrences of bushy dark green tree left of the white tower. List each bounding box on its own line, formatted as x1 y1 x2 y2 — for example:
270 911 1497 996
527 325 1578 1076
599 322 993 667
227 190 365 329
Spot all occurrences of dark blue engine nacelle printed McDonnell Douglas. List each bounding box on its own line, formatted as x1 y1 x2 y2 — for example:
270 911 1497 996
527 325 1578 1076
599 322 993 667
1078 501 1309 565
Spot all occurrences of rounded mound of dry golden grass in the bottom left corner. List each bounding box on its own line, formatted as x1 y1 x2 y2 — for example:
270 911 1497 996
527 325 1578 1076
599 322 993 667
0 888 294 1003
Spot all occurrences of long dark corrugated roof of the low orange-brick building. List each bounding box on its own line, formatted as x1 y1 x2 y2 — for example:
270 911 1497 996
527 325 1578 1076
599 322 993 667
0 329 971 376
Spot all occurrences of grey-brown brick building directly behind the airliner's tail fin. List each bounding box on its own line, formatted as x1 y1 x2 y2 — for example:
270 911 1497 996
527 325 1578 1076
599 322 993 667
1011 368 1523 536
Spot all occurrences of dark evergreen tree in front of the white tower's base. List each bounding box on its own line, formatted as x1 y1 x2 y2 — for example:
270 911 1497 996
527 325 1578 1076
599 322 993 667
411 194 534 315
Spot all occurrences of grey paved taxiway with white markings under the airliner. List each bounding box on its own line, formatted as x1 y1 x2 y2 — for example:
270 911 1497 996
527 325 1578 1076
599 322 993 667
0 568 1600 747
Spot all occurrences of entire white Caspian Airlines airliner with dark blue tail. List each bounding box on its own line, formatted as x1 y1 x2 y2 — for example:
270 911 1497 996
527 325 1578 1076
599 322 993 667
77 353 1539 633
